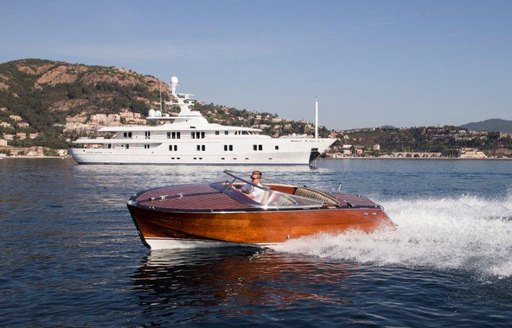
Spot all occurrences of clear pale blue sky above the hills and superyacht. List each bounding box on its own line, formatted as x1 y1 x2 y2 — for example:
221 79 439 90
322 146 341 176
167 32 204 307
0 0 512 130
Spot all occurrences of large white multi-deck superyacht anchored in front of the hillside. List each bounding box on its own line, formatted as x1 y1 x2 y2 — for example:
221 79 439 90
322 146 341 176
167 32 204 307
70 76 336 165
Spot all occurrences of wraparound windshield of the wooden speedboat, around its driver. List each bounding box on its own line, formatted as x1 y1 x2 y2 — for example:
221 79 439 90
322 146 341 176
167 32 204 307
223 170 324 209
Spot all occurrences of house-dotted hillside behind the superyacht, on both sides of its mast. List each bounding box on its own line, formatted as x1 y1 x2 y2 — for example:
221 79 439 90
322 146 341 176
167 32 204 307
0 59 328 148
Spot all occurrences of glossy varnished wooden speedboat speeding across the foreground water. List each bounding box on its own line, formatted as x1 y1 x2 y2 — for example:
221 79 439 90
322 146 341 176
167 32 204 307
127 170 393 249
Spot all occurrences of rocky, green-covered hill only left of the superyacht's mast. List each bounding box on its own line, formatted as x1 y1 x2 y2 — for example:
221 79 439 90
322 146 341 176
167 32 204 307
0 59 174 148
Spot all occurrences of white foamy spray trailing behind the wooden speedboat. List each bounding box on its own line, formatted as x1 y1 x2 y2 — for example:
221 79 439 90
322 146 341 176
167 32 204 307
273 192 512 278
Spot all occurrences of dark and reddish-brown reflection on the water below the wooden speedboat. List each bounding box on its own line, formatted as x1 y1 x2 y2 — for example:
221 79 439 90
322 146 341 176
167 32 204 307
133 247 350 315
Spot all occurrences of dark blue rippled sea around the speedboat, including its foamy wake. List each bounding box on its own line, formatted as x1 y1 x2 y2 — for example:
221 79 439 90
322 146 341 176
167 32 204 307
0 159 512 327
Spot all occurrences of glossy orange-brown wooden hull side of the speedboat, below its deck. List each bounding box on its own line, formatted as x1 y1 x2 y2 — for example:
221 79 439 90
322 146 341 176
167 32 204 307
128 204 391 249
